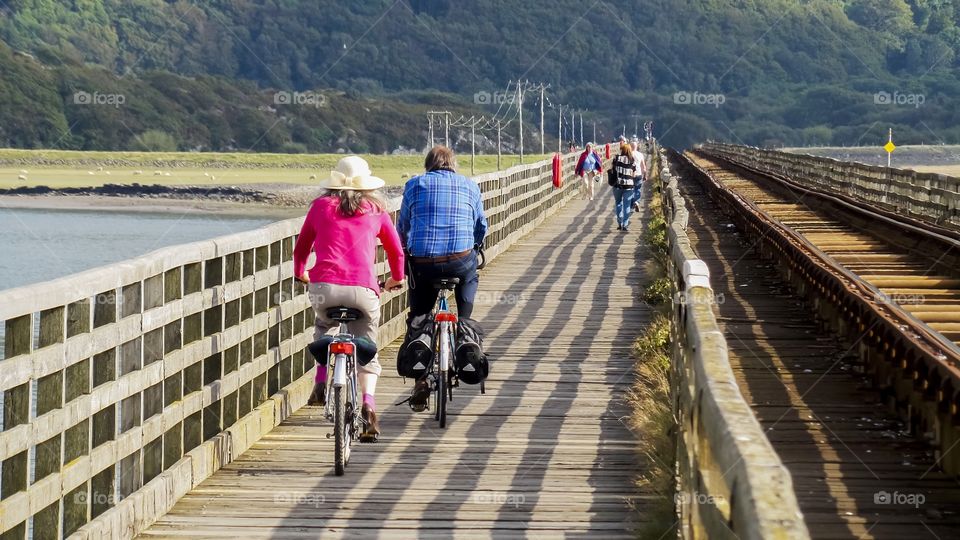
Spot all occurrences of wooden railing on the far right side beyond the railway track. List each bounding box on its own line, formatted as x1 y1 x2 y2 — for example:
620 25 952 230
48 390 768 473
702 143 960 230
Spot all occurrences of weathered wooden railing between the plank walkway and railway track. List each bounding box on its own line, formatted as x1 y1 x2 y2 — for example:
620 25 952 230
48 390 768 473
659 144 809 540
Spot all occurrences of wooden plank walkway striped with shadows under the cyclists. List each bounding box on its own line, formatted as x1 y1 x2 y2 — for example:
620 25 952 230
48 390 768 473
142 185 649 538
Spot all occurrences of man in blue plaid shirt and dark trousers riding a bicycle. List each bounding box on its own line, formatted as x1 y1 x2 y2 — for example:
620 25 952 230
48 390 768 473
397 146 487 411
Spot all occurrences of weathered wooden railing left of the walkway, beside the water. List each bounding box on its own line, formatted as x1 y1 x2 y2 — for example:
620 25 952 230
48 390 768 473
0 150 577 539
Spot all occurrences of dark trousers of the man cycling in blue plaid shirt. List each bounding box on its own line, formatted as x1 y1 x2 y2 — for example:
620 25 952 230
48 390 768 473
408 251 480 318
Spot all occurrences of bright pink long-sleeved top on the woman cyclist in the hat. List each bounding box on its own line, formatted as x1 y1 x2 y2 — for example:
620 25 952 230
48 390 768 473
293 197 404 295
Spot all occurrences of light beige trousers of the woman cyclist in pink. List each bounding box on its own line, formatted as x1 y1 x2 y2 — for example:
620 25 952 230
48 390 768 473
307 283 381 375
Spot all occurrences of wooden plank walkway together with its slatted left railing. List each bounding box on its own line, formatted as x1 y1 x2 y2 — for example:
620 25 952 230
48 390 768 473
0 154 660 538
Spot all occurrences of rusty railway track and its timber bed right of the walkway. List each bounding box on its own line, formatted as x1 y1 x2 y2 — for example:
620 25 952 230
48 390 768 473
676 155 960 539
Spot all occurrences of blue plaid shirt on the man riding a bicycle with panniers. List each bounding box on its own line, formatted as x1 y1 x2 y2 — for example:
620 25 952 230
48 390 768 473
397 170 487 257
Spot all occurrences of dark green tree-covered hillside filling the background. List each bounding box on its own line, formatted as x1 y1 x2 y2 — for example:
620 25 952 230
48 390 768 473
0 0 960 152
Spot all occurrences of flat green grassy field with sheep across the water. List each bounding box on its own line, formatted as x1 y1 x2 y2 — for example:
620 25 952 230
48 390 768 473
0 149 545 188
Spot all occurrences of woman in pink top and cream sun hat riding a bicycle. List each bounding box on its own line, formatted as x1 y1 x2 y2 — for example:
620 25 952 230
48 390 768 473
293 156 404 441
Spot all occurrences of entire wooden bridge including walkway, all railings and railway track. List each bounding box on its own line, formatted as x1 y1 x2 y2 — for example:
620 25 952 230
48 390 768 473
0 146 960 540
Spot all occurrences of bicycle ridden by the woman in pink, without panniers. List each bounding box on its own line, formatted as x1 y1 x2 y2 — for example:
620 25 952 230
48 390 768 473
323 306 363 476
